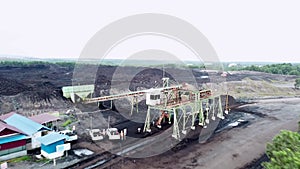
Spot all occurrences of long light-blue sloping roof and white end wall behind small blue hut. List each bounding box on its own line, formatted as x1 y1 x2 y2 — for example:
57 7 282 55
3 113 51 150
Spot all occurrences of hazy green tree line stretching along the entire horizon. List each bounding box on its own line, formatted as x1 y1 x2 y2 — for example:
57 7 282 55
0 60 300 76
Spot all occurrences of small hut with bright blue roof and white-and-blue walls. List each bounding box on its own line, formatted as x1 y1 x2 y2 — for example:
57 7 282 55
37 132 71 159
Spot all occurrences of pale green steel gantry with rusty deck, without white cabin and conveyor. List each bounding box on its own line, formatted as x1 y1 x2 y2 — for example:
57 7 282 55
143 79 228 139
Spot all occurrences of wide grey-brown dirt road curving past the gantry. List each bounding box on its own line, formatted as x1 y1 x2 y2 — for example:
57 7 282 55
114 98 300 169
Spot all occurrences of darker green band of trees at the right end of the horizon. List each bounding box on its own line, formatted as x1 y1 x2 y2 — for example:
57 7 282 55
229 63 300 76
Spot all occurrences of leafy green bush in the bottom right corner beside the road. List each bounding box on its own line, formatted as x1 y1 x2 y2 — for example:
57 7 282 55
262 130 300 169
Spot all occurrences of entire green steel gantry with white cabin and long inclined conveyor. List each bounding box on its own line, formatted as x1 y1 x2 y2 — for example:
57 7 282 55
84 78 228 140
